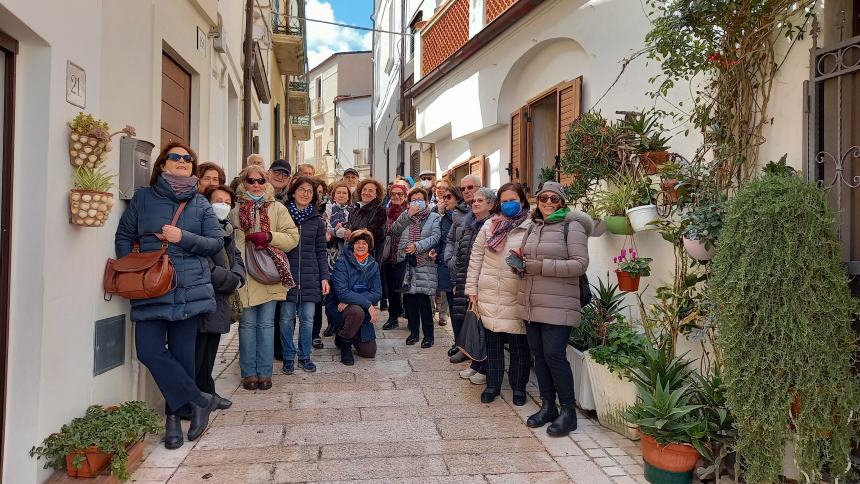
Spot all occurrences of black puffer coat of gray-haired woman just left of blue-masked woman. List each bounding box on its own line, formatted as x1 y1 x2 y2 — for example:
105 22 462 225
445 211 489 320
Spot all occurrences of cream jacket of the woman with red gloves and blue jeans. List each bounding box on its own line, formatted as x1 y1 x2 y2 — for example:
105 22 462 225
230 185 299 308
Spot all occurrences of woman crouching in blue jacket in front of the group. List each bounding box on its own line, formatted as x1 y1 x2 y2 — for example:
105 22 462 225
326 229 382 365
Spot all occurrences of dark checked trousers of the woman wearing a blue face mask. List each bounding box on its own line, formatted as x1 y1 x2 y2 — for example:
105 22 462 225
486 330 531 392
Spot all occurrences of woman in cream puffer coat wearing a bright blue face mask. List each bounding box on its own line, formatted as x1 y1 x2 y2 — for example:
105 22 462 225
465 183 531 406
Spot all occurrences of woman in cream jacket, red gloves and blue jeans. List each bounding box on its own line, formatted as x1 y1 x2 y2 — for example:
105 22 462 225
231 165 299 390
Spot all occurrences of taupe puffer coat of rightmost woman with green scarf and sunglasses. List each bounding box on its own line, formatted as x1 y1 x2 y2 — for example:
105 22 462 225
518 210 592 326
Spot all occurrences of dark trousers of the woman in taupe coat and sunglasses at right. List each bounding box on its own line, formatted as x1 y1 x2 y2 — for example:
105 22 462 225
526 322 576 405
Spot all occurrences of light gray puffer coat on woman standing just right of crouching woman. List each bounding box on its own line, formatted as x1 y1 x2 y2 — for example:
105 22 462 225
391 210 442 296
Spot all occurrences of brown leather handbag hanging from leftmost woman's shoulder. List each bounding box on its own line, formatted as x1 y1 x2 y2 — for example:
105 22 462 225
104 202 187 301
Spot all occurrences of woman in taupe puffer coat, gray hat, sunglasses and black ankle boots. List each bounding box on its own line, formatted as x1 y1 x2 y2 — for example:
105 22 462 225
519 181 592 437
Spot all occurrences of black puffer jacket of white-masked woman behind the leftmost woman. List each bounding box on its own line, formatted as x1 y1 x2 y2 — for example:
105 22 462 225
198 220 245 334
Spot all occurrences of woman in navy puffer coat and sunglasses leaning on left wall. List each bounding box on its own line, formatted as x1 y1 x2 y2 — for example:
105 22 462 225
115 143 224 449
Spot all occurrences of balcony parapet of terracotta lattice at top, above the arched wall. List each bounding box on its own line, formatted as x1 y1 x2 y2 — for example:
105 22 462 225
421 0 520 77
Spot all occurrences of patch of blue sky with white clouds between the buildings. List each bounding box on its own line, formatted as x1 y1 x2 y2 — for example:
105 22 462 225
305 0 373 69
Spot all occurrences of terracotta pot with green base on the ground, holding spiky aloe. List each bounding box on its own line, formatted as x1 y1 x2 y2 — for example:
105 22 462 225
640 434 701 484
